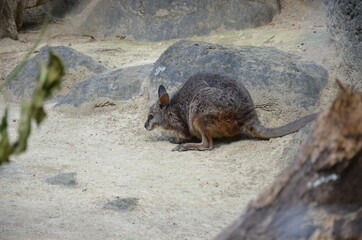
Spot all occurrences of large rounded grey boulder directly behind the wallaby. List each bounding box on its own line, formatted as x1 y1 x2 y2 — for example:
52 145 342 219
149 40 328 121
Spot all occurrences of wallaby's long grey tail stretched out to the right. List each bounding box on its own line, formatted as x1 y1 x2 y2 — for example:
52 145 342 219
248 113 319 139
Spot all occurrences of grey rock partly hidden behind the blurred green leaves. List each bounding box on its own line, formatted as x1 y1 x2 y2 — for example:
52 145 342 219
7 46 108 100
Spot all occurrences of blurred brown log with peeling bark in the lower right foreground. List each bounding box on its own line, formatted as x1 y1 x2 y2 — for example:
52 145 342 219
215 85 362 240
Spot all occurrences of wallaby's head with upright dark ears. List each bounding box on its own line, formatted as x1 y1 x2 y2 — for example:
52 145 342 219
145 85 170 131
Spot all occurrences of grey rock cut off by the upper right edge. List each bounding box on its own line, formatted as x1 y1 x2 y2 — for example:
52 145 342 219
324 0 362 91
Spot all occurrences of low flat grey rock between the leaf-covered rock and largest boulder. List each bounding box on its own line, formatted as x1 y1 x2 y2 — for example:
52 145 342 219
56 64 153 107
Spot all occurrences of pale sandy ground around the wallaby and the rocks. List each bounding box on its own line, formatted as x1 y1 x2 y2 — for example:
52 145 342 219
0 1 337 239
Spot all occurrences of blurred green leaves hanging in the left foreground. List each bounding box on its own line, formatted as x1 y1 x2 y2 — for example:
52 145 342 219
0 51 64 164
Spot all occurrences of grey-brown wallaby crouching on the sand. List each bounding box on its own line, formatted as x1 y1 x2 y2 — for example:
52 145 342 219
145 73 317 151
